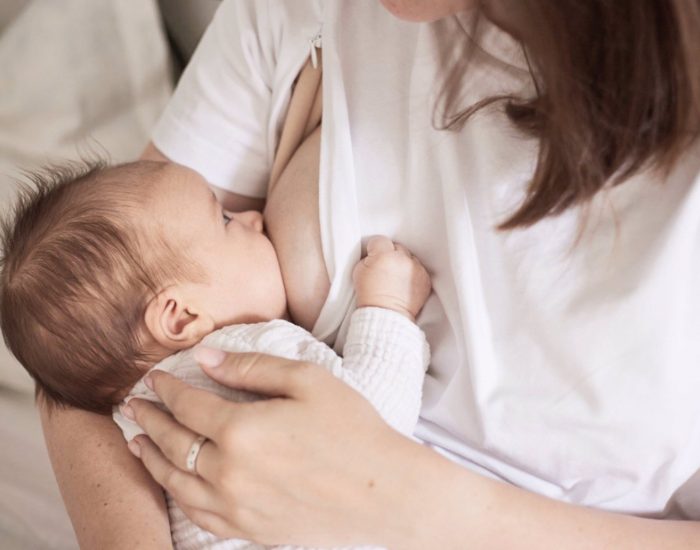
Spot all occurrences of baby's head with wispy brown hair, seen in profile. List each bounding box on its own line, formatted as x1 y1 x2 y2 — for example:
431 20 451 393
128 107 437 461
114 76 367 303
0 161 286 414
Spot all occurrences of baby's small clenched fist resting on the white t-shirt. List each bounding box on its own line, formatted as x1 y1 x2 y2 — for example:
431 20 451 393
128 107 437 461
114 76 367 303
352 237 431 320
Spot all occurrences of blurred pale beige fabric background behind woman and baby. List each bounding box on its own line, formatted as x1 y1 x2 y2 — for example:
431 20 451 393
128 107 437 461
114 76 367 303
0 0 219 550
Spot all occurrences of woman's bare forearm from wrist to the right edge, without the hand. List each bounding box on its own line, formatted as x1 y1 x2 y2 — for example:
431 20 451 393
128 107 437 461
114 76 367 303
394 440 700 550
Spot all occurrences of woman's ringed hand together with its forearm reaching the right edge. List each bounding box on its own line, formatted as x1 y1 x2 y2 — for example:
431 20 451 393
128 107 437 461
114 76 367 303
124 348 700 550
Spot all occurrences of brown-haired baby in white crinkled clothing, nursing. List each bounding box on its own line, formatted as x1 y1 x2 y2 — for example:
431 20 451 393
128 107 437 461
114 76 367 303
0 161 430 549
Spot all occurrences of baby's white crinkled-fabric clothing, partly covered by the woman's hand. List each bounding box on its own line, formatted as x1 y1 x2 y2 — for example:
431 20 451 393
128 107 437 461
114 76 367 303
114 307 430 550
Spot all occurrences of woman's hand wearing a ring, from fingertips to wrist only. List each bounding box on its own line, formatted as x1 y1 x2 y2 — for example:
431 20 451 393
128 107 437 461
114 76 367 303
124 348 424 546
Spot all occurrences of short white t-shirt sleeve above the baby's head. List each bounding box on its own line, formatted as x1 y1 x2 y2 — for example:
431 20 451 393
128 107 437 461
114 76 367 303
152 0 275 197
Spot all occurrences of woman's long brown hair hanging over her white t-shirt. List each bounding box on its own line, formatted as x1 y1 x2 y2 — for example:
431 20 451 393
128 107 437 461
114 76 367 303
442 0 700 229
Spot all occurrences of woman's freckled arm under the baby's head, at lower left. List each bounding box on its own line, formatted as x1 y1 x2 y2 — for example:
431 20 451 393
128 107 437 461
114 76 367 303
39 400 172 549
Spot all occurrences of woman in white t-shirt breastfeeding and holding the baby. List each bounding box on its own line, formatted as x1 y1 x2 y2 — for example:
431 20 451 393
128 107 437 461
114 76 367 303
43 0 700 549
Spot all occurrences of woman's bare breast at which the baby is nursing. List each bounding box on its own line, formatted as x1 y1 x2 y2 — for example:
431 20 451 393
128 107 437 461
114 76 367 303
264 126 330 330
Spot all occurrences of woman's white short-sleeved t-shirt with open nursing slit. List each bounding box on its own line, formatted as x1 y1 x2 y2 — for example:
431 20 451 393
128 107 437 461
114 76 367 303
153 0 700 519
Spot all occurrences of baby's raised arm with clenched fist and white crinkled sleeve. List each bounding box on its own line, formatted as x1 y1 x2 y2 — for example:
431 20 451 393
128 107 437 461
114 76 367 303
334 237 430 435
